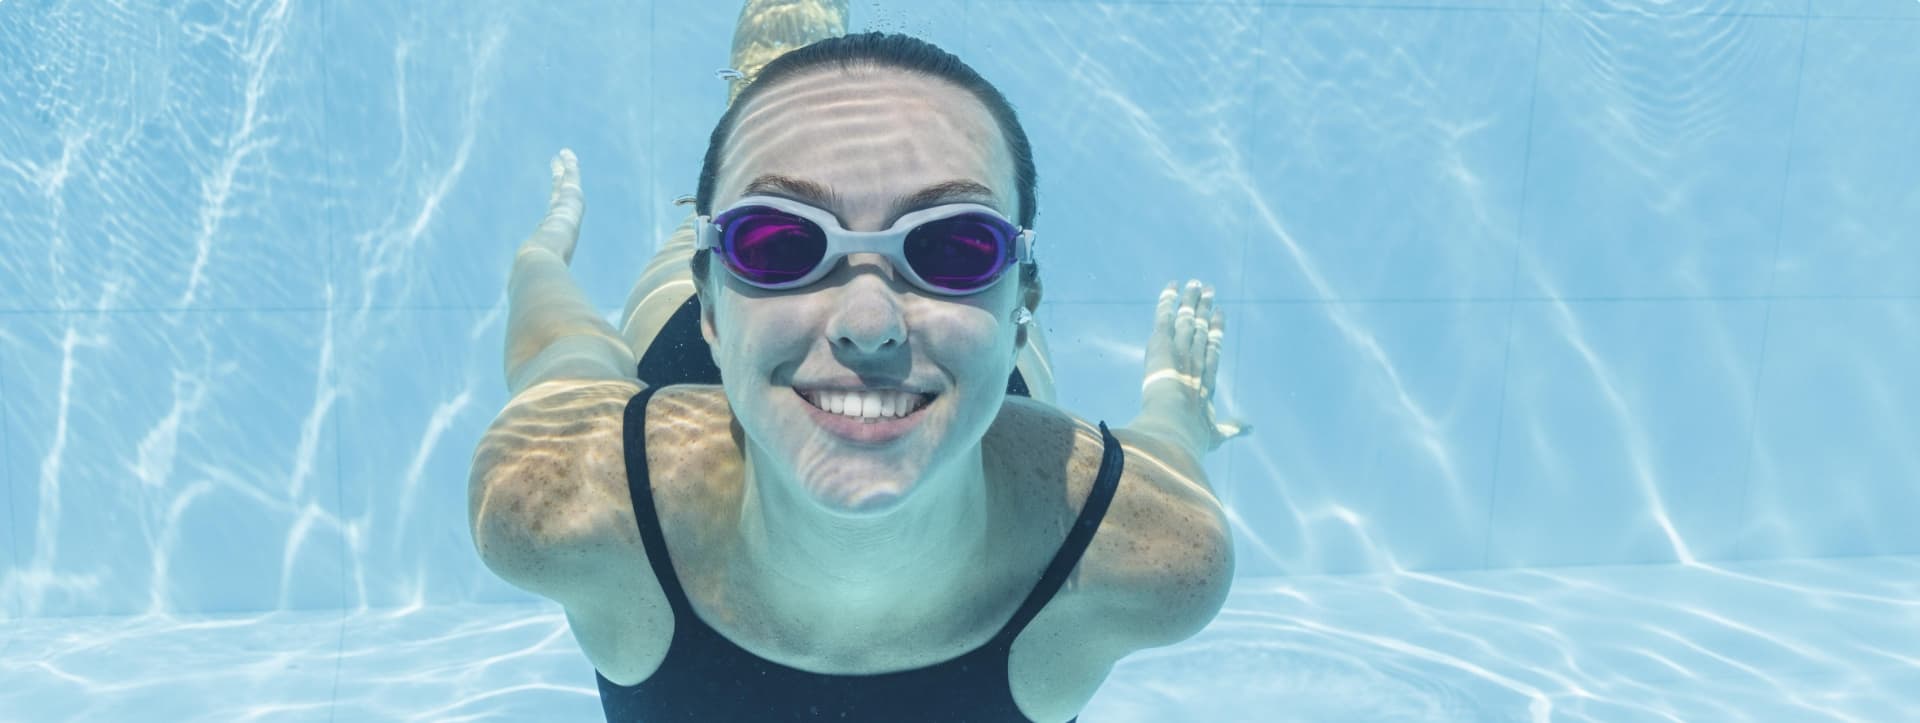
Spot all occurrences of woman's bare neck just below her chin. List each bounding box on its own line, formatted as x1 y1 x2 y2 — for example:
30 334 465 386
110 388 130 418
735 447 989 621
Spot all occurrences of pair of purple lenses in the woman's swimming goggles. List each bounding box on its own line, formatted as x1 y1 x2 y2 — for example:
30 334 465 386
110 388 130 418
714 205 1016 293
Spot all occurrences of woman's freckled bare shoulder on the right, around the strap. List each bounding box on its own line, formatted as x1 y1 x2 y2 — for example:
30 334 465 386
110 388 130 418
991 397 1233 654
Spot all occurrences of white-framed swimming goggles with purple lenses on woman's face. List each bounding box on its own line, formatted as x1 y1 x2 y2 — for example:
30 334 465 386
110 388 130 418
693 196 1033 295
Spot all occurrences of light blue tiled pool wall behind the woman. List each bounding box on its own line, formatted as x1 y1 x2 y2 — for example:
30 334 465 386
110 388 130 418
0 0 1920 616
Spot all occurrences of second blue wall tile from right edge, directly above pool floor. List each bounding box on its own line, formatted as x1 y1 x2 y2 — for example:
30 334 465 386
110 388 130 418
1486 301 1766 568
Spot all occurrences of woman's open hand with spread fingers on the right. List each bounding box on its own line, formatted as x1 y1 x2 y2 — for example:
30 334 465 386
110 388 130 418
1133 280 1254 455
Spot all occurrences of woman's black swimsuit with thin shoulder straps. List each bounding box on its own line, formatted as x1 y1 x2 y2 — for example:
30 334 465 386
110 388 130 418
595 295 1121 723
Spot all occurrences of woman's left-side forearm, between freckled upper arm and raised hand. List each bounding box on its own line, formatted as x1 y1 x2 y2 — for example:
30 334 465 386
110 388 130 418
505 244 636 393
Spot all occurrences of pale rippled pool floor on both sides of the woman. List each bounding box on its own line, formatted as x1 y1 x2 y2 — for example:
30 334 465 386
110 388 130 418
0 556 1920 723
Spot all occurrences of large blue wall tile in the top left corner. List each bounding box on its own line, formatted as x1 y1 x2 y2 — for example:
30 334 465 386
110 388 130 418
0 6 326 311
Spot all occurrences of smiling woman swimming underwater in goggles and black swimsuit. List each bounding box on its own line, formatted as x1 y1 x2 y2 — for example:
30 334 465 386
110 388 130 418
470 2 1244 721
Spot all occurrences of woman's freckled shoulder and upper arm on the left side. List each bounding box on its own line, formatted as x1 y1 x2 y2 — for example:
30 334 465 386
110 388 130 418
468 373 645 606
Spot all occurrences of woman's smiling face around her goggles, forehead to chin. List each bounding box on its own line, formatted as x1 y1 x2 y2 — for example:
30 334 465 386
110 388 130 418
703 69 1021 512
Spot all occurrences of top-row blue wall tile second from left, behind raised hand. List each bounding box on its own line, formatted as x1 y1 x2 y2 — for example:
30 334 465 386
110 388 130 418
326 2 653 309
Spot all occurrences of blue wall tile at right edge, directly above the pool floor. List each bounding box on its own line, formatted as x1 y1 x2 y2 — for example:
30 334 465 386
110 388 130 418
1741 301 1920 558
